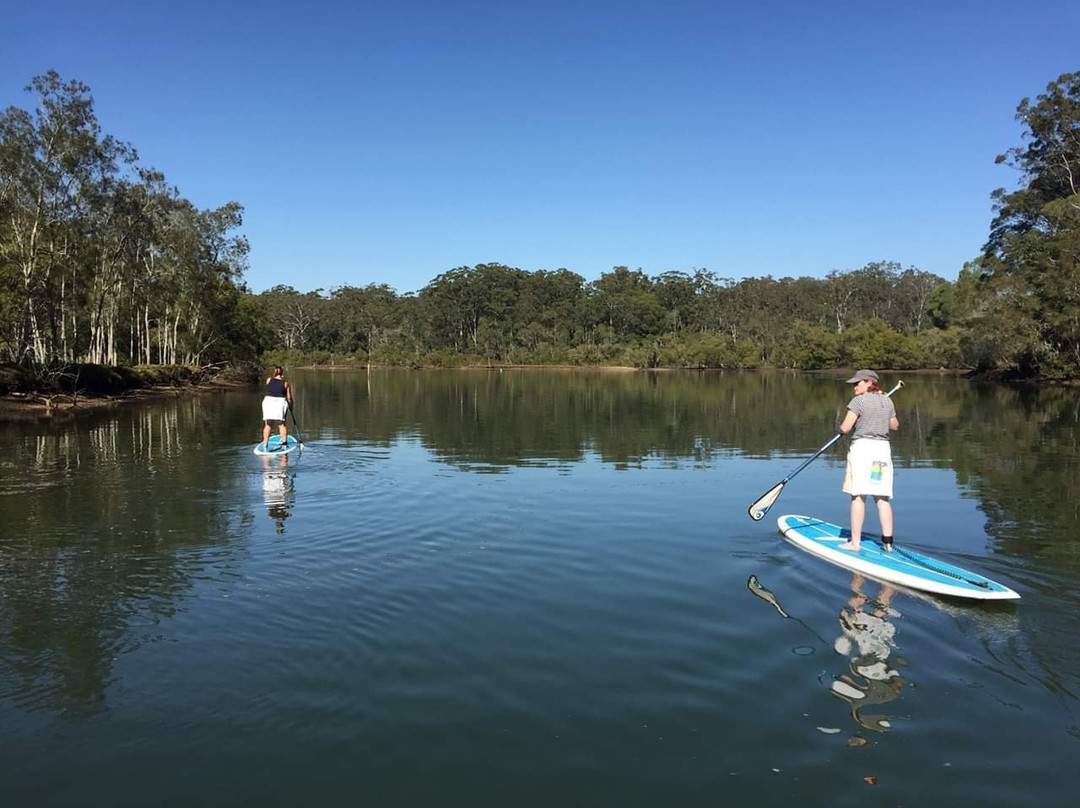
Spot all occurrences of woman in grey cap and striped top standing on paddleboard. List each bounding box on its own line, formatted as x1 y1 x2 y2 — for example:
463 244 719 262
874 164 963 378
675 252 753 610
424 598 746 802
840 371 900 552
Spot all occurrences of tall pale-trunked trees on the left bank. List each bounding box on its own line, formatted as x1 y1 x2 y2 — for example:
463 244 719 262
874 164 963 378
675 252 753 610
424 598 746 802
0 71 254 365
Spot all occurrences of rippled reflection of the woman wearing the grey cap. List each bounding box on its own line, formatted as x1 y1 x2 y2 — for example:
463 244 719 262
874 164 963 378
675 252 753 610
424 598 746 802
832 574 904 732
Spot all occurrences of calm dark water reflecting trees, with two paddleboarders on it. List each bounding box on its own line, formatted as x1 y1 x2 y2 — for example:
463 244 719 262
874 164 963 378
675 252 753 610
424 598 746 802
0 372 1080 806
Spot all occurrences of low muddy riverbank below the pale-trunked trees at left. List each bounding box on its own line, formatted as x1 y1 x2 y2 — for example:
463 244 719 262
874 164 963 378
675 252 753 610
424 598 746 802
0 364 259 420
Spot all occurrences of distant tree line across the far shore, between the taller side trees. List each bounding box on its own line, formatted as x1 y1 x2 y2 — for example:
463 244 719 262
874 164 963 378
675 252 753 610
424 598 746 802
256 261 962 368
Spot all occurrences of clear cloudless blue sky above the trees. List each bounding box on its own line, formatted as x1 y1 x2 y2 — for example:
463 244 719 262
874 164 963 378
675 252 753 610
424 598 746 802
0 0 1080 292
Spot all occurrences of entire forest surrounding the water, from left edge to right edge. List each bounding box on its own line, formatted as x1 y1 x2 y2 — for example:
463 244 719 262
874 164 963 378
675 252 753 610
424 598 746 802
0 72 1080 379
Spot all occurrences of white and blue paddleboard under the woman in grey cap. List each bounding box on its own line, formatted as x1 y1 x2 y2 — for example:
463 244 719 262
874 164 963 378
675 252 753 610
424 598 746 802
777 514 1020 601
